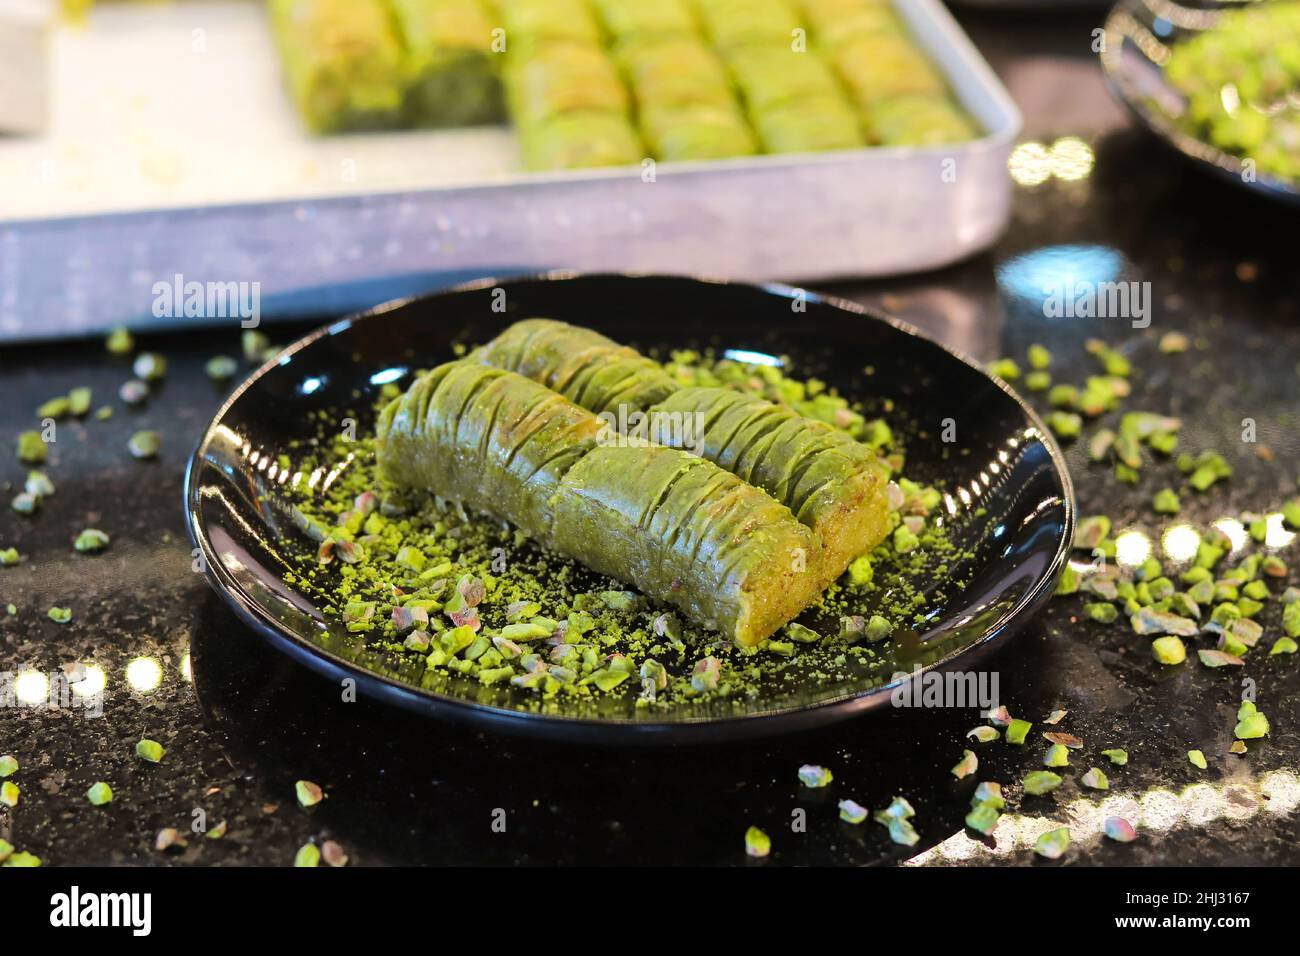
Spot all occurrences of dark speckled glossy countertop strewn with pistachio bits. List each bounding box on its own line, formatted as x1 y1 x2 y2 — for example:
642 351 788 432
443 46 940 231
0 12 1300 865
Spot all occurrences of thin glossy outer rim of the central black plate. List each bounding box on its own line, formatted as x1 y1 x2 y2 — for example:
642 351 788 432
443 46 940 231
182 269 1078 744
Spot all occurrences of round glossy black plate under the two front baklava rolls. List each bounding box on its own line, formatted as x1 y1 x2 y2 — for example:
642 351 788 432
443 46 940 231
185 276 1074 741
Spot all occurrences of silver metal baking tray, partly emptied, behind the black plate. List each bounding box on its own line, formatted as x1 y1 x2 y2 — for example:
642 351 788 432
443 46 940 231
0 0 1021 341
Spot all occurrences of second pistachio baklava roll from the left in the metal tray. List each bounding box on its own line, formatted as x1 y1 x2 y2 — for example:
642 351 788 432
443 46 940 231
389 0 506 127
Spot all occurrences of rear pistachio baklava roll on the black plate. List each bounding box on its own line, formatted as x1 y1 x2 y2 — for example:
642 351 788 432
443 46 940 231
469 319 888 575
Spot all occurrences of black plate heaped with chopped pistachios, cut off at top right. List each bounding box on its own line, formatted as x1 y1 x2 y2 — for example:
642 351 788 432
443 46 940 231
1101 0 1300 203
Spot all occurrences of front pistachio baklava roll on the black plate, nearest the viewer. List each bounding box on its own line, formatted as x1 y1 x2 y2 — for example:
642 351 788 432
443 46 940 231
377 362 829 645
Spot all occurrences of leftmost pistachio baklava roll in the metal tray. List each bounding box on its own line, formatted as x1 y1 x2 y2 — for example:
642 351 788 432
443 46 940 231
267 0 407 133
